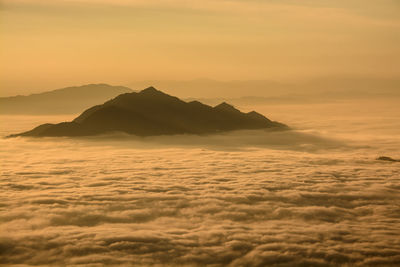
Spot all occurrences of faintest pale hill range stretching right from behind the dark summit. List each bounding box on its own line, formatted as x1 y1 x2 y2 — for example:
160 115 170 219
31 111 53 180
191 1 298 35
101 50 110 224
127 75 400 101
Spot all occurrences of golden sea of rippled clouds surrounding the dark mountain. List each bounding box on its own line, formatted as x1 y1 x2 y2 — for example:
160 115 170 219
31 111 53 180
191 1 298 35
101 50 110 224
0 99 400 266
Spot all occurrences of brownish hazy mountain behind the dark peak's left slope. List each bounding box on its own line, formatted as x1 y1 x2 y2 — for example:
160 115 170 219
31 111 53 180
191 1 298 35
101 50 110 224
0 84 132 115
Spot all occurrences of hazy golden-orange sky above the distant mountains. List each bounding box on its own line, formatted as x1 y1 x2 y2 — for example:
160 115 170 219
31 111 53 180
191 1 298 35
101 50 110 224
0 0 400 95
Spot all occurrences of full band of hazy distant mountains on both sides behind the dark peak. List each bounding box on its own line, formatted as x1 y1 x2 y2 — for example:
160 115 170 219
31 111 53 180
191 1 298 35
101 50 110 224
0 77 400 115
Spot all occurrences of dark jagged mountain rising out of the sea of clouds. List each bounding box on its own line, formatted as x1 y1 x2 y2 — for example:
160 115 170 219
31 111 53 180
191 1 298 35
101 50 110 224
11 87 288 137
